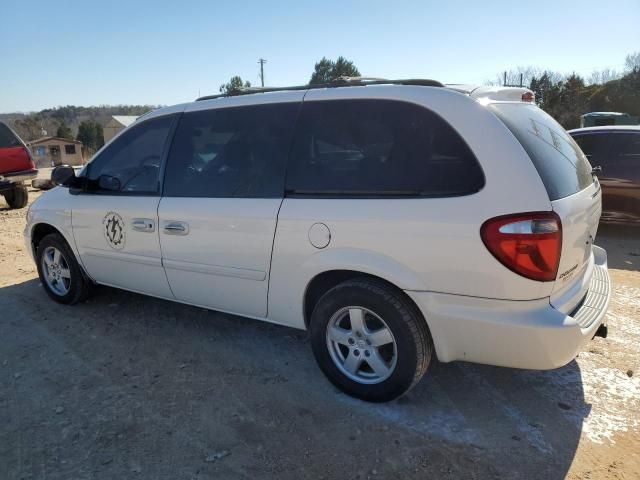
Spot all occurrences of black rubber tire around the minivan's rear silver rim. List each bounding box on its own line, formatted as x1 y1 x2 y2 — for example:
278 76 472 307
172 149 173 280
309 277 433 402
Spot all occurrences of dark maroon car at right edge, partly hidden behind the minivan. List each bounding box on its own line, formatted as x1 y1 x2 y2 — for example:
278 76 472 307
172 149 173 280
569 125 640 226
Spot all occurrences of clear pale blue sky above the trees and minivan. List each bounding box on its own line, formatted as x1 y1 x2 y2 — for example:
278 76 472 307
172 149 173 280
0 0 640 113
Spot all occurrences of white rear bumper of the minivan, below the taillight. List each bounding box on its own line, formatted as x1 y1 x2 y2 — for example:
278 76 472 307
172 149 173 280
407 246 611 370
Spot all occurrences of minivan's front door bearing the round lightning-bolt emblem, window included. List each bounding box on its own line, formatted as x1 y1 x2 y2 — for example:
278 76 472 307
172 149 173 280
72 115 175 298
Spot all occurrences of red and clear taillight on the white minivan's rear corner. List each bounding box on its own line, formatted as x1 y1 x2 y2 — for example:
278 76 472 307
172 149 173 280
480 212 562 282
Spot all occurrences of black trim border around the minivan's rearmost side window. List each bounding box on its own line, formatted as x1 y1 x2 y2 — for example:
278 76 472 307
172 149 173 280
284 95 487 200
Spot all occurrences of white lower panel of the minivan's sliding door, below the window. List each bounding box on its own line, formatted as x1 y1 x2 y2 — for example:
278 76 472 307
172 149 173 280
159 197 282 317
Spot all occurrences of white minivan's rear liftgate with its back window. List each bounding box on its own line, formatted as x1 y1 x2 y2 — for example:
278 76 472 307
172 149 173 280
489 103 602 311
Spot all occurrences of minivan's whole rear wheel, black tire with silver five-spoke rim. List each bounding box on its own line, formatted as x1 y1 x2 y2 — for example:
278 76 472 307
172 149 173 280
309 278 433 402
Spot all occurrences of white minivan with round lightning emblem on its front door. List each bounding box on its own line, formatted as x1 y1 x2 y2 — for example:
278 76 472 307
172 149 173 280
25 80 610 401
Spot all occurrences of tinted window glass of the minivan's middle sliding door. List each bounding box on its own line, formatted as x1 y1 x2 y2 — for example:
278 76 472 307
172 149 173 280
164 103 300 198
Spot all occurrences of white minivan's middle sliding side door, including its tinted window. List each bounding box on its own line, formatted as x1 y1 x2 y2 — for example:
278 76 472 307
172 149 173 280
159 92 304 318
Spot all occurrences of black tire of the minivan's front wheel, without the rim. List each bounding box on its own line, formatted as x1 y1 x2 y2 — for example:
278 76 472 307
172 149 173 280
36 233 91 305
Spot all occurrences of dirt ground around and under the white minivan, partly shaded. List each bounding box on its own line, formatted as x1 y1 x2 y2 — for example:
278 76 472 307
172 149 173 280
0 192 640 480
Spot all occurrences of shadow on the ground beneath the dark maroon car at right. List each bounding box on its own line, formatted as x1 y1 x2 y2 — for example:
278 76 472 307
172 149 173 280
595 224 640 271
